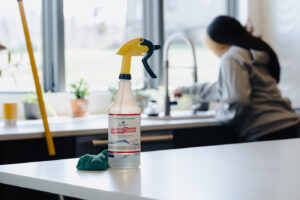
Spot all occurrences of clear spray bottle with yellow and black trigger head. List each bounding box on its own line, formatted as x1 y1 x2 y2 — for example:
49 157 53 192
108 38 160 168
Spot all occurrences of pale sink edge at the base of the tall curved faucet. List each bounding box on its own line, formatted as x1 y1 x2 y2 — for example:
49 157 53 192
142 110 216 120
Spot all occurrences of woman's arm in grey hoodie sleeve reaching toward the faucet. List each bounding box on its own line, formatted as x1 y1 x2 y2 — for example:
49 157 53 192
175 57 251 105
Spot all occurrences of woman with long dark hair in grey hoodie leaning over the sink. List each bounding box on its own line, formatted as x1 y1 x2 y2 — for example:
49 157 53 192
174 16 300 141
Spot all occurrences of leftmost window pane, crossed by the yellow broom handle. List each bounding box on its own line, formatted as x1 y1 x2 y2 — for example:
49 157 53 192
0 0 42 91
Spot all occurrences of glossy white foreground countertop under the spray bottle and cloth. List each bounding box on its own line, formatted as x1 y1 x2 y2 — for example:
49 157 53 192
0 139 300 200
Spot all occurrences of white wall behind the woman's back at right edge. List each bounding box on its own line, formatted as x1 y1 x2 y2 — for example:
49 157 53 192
249 0 300 108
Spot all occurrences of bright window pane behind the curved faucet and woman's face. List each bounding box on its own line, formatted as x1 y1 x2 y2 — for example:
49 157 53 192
164 0 228 89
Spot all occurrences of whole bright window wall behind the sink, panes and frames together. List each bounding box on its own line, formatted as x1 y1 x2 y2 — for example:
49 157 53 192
0 0 235 91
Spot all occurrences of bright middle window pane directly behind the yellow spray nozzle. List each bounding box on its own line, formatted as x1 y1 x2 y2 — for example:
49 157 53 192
64 0 143 90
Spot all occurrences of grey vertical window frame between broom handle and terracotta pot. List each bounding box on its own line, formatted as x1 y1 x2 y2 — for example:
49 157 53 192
42 0 65 92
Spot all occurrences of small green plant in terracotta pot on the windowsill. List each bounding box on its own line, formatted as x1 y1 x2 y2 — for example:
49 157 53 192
70 78 89 117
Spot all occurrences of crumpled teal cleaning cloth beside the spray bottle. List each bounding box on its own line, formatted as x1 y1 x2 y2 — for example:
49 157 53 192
76 149 109 171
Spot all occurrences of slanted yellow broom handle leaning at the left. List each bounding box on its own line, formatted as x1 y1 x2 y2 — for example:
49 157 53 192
18 0 56 156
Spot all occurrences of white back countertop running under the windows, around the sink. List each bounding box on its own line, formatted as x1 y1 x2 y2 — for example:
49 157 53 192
0 111 221 141
